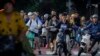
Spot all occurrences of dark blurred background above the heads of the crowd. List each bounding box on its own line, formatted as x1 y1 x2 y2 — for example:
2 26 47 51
0 0 100 18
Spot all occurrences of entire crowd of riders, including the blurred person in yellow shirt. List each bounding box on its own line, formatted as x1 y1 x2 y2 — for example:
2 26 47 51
0 1 100 56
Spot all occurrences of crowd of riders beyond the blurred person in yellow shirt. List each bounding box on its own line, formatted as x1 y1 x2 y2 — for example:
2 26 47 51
21 10 100 56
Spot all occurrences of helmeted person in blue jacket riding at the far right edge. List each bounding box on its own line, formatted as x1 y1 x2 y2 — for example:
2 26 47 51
85 14 100 56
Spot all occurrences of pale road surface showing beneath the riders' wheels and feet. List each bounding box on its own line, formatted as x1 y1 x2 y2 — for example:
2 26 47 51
35 41 100 56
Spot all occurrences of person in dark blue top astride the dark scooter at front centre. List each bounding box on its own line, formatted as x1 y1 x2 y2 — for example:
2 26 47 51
54 13 69 55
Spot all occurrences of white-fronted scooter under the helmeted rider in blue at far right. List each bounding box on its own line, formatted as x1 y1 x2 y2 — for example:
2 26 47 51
78 31 91 56
